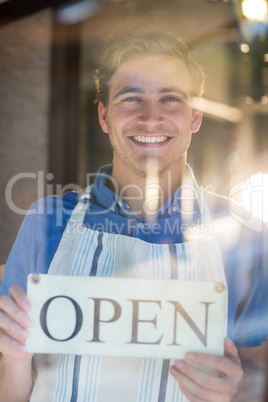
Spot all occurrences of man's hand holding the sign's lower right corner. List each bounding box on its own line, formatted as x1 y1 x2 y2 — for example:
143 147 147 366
170 338 243 402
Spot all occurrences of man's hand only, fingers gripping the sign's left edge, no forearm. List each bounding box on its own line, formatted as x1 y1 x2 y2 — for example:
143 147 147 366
0 285 31 360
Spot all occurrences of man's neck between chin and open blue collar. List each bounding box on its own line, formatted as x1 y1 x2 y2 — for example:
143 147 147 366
112 157 186 219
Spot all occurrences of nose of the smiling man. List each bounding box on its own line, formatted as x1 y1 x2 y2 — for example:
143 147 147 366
138 101 164 130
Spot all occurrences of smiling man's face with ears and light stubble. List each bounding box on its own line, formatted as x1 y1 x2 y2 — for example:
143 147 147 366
99 55 202 177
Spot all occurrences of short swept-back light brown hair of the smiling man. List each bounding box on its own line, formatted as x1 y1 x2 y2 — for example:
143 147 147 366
95 32 204 106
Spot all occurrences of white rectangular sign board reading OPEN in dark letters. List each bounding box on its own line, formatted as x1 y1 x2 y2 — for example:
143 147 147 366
26 274 227 358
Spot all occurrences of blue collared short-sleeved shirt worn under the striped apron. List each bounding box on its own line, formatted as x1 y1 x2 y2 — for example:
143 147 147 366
0 166 268 347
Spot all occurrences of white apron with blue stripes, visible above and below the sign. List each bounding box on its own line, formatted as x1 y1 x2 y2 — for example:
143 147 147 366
31 178 227 402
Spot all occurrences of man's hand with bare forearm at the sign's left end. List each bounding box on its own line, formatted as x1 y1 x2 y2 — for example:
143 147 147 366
0 285 33 402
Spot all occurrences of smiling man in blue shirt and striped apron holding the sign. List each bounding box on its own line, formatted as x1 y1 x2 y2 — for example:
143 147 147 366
0 33 267 402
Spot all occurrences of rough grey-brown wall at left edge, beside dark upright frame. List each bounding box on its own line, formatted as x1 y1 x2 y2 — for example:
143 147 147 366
0 10 51 264
